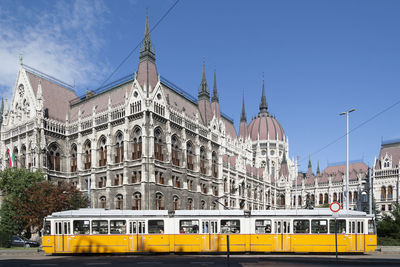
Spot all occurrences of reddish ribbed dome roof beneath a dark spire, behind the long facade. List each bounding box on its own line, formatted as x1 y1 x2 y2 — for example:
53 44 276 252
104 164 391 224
248 112 285 141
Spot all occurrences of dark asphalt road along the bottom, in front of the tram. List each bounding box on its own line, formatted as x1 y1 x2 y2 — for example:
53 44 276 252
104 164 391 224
0 253 400 267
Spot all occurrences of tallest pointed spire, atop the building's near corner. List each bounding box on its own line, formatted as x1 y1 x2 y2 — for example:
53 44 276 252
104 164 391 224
136 14 158 96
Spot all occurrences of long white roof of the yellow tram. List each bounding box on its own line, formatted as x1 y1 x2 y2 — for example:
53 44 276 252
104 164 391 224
47 208 373 218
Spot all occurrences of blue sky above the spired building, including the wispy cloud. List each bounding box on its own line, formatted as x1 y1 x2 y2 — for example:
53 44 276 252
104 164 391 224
0 0 400 171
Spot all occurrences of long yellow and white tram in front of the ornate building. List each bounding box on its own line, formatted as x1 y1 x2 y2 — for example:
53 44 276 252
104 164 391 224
42 209 377 254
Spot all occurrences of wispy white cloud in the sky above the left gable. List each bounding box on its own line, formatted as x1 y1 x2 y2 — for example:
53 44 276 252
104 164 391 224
0 1 108 99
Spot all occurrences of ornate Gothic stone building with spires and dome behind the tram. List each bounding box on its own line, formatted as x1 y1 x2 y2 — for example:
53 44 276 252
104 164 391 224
0 16 376 210
